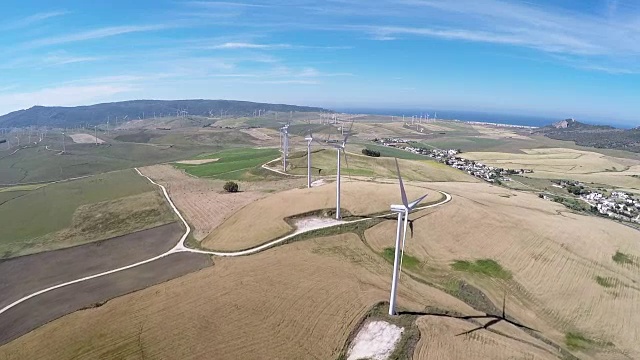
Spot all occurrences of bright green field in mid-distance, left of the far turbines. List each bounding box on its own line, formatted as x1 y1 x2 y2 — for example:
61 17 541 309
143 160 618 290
174 148 280 180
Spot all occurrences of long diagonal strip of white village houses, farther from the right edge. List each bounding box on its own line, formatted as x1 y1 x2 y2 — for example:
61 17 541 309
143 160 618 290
374 138 533 183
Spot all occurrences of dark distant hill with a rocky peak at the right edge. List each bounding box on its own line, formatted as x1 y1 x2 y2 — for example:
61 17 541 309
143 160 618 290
538 119 640 153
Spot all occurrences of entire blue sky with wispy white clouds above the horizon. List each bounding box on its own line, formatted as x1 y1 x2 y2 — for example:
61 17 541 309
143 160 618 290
0 0 640 126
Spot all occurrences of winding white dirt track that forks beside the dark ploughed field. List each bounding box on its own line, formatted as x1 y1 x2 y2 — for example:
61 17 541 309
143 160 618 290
0 168 451 314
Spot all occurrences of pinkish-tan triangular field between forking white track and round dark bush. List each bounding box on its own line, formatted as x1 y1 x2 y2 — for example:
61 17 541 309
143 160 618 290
140 165 265 240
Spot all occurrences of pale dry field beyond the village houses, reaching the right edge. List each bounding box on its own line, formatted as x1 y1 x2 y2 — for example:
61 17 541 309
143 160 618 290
461 148 640 191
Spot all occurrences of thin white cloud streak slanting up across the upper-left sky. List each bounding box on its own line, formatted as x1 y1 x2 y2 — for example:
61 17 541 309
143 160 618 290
26 25 170 47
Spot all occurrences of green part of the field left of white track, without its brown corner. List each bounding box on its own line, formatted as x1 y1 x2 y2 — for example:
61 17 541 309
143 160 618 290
0 170 171 253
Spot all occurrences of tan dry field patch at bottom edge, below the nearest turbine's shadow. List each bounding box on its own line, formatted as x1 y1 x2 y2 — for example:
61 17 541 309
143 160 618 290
414 316 558 360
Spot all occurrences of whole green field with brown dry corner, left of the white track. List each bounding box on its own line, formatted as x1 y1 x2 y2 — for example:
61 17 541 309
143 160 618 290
0 170 175 257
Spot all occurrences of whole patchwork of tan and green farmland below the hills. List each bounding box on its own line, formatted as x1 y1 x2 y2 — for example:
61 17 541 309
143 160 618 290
0 115 640 359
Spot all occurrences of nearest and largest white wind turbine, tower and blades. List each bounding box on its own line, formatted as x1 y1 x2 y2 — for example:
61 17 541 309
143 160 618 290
389 159 428 315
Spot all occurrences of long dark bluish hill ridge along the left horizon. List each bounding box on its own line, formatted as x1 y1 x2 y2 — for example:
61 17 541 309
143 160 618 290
0 99 327 128
